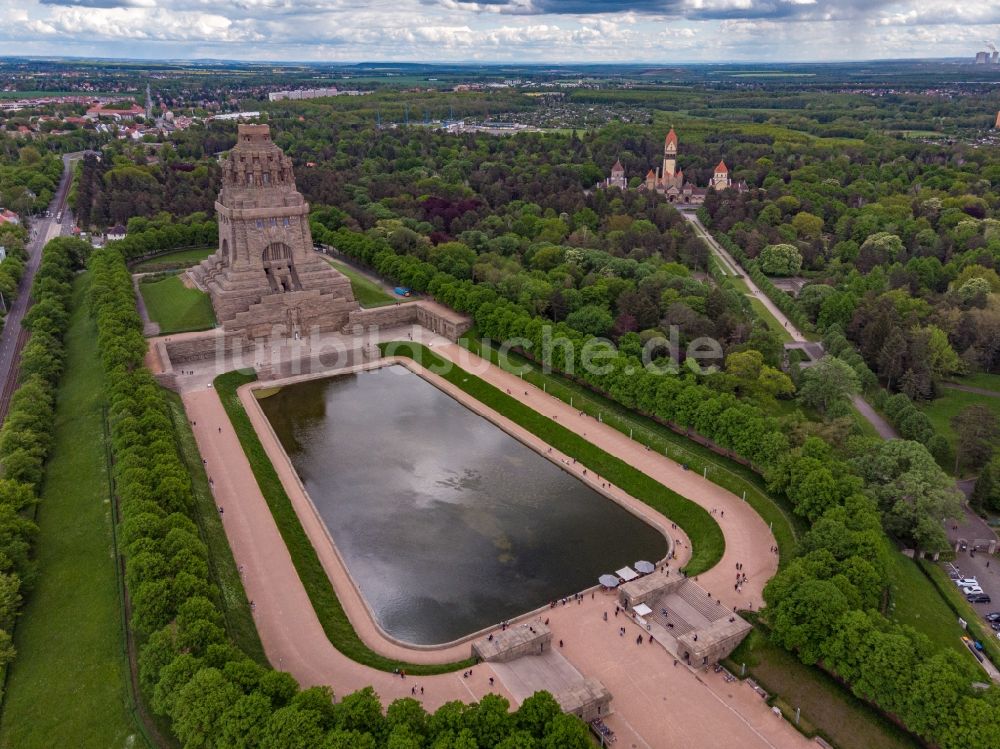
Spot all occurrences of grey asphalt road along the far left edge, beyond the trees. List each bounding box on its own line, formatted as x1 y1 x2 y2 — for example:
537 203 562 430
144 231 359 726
0 154 79 422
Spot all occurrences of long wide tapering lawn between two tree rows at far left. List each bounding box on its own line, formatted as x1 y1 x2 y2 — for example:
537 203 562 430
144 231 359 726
0 277 146 749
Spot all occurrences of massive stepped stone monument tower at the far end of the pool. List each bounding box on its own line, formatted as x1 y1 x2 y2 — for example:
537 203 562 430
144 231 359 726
191 125 359 338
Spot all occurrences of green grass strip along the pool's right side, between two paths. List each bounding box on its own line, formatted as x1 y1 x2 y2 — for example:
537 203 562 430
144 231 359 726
381 342 726 576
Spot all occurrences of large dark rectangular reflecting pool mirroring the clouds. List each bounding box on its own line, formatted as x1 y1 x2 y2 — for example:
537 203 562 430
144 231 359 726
260 365 667 645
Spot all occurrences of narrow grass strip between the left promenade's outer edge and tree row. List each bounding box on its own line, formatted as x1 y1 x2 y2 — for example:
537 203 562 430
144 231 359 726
164 390 270 666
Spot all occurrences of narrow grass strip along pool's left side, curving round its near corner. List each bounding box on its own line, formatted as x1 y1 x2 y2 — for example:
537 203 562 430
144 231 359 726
215 372 472 676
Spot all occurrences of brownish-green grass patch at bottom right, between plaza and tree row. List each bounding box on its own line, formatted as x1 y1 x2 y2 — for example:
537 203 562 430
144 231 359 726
729 627 920 749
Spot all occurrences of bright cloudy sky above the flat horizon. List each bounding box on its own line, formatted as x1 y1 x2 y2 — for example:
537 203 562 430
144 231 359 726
0 0 1000 63
